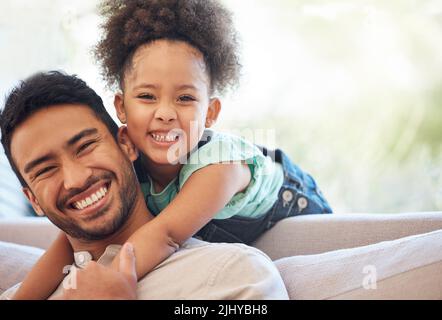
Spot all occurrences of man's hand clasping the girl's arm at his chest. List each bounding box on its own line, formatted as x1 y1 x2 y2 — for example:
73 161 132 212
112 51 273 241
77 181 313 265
55 243 137 300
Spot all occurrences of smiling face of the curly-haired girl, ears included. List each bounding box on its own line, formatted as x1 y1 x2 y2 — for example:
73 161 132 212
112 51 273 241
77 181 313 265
115 40 221 165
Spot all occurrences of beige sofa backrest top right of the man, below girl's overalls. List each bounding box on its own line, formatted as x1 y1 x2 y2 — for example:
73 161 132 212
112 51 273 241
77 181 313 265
253 212 442 260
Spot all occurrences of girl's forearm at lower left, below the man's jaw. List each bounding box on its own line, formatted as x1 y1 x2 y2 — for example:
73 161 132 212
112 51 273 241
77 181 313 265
12 232 74 300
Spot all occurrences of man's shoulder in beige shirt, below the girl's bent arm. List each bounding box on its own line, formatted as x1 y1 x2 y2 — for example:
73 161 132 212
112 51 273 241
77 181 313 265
138 238 287 300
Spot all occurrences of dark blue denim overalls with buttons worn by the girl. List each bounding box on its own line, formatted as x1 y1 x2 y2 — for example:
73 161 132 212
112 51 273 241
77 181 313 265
135 136 332 244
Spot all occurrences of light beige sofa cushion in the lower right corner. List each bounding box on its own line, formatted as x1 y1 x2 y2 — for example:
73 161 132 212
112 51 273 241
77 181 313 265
275 230 442 299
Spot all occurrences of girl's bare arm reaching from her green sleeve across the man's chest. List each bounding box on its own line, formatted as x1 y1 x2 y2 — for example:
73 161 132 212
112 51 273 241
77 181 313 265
112 163 251 279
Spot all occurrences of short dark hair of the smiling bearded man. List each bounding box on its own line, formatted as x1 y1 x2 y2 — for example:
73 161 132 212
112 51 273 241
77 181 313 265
0 71 118 187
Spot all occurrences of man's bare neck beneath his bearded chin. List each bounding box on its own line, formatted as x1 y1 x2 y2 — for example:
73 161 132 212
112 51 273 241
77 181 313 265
68 191 154 260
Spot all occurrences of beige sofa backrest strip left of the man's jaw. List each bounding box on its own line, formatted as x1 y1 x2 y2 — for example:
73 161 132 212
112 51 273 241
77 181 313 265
0 217 59 249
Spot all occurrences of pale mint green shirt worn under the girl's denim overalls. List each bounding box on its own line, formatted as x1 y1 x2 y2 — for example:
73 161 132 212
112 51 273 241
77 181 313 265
140 130 284 219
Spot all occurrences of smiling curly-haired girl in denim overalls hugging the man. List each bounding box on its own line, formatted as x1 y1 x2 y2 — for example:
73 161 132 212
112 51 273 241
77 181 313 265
15 0 332 299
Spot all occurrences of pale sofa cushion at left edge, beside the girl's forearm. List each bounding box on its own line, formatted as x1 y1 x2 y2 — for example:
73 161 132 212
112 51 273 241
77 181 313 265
0 241 44 294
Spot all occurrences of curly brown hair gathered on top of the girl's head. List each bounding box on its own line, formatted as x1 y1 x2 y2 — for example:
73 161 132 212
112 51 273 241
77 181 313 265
95 0 241 94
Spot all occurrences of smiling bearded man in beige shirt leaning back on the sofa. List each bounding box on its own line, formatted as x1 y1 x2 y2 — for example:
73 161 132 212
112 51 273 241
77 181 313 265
1 72 287 299
